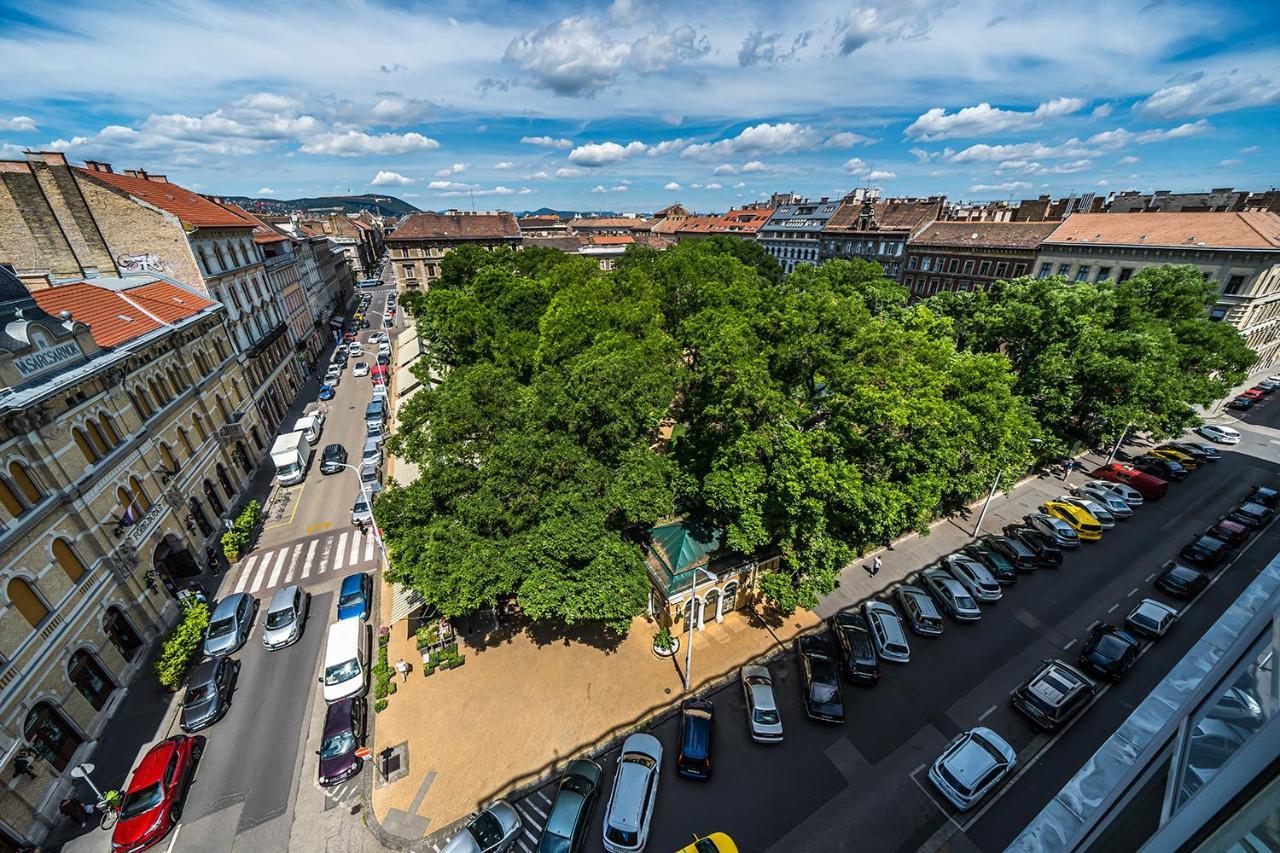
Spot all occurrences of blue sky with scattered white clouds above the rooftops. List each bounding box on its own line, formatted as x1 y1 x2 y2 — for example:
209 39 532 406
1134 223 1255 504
0 0 1280 211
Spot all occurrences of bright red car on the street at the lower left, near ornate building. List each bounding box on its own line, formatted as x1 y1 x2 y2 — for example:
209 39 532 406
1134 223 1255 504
111 735 204 853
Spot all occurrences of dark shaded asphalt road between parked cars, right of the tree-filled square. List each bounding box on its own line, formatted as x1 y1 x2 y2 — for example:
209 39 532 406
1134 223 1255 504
499 394 1280 850
